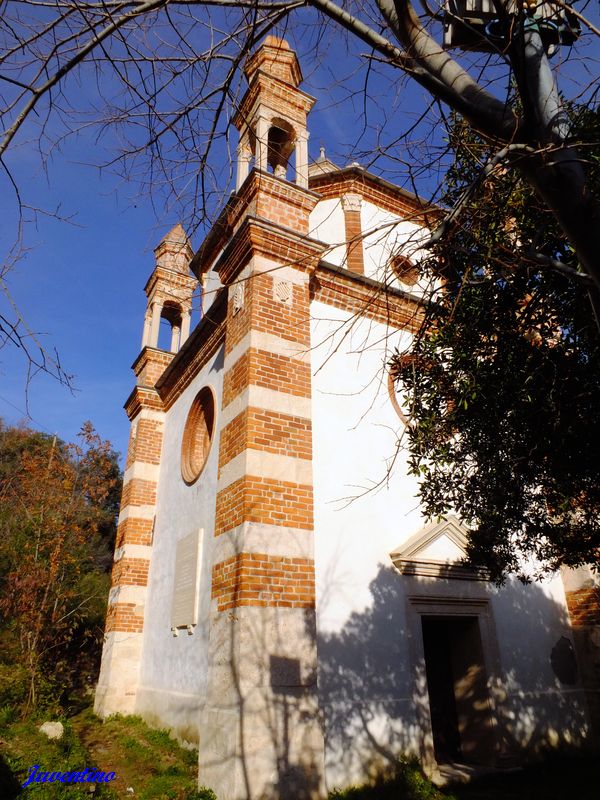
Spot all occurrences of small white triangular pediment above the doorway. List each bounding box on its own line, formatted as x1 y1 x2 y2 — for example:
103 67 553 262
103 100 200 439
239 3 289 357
390 517 489 581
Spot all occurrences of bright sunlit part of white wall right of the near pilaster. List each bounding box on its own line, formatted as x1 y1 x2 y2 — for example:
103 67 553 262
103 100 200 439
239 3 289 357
311 303 422 631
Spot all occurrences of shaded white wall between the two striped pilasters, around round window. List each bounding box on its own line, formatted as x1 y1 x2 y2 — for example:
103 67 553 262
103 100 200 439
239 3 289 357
136 347 223 742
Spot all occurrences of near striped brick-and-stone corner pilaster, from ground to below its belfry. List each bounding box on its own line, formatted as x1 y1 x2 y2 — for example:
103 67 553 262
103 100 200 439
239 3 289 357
199 155 324 800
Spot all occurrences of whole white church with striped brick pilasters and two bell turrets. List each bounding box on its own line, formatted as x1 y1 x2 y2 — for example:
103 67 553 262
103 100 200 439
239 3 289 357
96 37 600 800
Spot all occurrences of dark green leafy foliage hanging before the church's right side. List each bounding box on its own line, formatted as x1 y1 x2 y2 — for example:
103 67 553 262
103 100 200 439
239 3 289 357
392 109 600 580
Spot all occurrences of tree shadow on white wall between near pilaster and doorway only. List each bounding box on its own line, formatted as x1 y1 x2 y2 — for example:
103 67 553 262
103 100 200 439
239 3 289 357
317 567 419 780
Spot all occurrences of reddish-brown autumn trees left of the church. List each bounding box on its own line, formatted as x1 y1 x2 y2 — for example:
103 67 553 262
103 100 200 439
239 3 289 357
0 423 121 708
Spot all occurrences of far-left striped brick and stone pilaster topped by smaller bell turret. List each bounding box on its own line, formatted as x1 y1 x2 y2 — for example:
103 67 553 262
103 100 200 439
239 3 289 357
94 225 198 717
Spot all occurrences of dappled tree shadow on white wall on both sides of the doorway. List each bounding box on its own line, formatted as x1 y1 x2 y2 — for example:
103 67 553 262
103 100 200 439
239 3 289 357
318 566 588 784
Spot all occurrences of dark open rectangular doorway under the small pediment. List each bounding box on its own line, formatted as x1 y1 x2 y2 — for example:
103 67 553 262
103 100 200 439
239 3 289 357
421 615 495 764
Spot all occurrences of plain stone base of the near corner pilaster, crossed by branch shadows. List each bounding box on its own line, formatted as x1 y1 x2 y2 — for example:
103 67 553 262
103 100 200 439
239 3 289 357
200 607 323 800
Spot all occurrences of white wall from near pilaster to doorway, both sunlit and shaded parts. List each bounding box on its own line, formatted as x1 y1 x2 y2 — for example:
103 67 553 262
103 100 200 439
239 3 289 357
311 303 423 789
